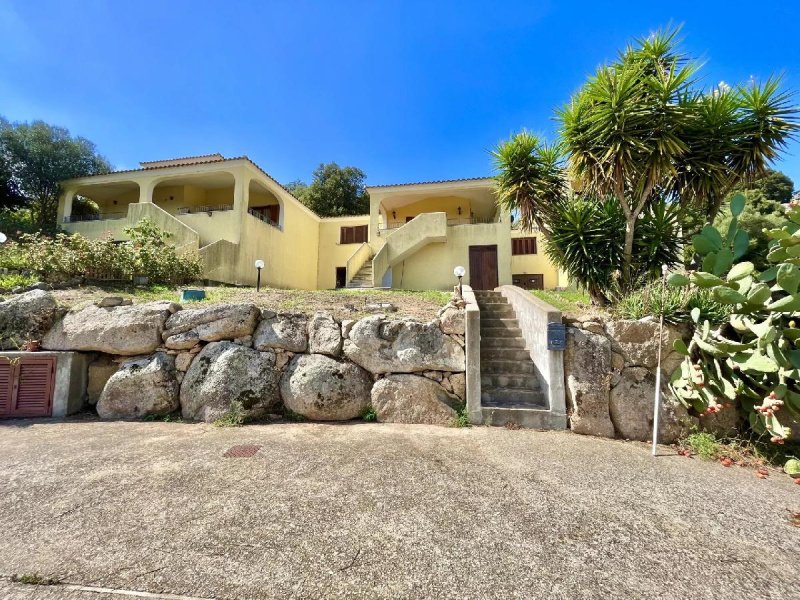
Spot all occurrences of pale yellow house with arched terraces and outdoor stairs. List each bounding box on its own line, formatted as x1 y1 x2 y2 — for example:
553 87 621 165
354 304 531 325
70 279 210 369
58 154 566 290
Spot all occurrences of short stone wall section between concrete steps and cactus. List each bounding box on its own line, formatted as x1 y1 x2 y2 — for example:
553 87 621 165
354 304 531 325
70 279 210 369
564 318 699 443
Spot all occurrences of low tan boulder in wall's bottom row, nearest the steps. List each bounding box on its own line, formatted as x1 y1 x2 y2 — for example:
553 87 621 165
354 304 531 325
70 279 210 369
372 375 461 425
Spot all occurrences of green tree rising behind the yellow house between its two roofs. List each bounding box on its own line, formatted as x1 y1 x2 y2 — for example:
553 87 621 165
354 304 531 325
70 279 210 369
294 163 369 217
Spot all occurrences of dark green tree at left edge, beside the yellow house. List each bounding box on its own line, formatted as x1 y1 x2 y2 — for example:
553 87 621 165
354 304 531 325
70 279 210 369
0 121 111 230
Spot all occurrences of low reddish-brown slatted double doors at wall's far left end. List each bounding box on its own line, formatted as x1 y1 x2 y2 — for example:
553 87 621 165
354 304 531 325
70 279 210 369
0 356 56 419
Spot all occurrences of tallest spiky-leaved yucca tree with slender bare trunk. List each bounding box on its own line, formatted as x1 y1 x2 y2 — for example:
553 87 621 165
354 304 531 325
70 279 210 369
558 30 797 286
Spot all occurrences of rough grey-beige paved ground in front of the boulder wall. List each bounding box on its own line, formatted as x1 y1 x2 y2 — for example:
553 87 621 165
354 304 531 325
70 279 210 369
0 421 800 600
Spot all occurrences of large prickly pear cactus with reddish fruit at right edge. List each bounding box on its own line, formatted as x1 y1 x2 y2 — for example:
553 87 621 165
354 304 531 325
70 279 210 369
667 194 800 444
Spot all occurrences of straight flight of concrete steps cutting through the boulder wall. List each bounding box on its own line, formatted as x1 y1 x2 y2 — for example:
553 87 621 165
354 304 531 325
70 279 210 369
475 291 549 427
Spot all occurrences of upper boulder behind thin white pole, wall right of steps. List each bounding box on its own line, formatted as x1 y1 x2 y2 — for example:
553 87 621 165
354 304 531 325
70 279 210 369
606 318 687 375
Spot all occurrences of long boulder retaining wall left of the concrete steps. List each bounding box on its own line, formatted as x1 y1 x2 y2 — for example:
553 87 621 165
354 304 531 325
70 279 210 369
0 290 466 425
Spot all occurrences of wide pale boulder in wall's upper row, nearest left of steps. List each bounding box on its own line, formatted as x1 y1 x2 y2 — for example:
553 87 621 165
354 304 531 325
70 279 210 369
344 315 465 373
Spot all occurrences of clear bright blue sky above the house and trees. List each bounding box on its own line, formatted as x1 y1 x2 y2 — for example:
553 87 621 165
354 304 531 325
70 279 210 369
0 0 800 187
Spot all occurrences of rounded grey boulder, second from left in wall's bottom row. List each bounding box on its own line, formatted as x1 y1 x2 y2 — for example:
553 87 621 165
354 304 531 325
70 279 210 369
181 342 280 423
